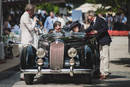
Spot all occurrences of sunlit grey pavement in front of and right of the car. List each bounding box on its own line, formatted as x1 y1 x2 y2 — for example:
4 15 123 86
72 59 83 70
0 37 130 87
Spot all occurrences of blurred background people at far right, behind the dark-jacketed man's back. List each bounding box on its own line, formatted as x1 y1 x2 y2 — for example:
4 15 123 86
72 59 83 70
99 13 128 30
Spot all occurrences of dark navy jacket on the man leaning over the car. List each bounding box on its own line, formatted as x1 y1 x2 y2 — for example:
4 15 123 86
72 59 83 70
86 17 112 45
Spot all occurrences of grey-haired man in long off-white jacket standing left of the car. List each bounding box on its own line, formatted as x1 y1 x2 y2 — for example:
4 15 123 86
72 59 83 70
20 4 38 79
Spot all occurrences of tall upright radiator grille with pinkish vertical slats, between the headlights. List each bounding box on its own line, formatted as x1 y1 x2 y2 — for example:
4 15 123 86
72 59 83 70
50 42 64 70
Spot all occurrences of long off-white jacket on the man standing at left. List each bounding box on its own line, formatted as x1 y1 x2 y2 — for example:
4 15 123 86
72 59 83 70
20 12 36 45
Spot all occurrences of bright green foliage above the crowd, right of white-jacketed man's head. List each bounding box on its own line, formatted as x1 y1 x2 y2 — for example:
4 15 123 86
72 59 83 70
36 3 59 13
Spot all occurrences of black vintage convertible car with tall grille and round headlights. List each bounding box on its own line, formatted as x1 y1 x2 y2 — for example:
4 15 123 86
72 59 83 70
21 32 99 84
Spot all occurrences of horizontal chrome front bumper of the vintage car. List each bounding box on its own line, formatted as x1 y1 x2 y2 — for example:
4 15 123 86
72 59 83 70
21 69 92 74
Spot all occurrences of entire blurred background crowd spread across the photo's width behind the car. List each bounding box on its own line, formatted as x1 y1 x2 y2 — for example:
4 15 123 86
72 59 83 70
3 6 128 47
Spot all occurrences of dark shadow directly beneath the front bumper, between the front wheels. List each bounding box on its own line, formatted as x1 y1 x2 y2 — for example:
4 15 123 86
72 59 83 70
34 75 93 84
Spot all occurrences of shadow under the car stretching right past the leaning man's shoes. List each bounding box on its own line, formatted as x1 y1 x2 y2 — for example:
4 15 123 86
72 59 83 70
34 75 127 87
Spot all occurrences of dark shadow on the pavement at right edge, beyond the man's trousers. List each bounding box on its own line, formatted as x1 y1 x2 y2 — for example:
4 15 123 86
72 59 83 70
110 58 130 67
